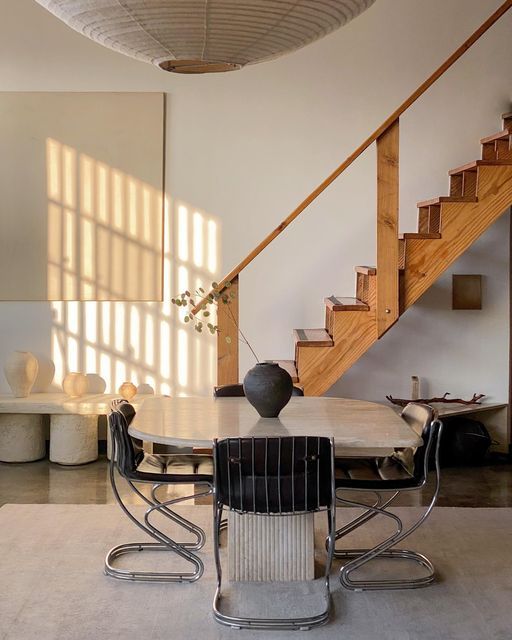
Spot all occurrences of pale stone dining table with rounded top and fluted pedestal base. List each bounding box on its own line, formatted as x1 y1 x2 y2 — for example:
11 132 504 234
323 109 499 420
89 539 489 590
129 396 422 581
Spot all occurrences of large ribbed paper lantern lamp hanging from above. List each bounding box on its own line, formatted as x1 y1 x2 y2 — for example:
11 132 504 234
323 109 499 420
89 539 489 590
33 0 375 73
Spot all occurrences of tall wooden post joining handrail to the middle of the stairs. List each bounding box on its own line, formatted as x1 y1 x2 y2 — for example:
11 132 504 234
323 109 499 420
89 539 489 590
377 119 399 338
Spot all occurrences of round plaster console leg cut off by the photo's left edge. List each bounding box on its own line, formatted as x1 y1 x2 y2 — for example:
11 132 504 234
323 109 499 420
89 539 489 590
0 413 46 462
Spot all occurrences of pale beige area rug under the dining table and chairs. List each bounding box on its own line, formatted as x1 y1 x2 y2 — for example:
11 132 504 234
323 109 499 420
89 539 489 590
0 505 512 640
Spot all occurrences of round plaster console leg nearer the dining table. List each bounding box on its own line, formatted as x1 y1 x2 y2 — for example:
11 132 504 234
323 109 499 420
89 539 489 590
50 414 98 464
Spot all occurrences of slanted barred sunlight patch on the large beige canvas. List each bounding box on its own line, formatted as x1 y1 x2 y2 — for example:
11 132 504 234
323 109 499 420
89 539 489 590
46 138 163 300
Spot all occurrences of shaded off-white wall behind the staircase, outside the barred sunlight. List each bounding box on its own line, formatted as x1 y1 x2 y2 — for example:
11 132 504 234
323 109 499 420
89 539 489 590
0 0 512 400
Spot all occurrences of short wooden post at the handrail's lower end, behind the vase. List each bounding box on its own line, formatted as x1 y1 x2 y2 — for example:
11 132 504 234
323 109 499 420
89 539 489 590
217 276 239 385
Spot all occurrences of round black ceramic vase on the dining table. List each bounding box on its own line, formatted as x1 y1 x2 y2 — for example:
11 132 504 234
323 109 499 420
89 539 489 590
244 362 293 418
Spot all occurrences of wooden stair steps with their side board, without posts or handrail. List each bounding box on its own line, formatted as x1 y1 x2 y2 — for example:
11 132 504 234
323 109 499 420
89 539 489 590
286 113 512 395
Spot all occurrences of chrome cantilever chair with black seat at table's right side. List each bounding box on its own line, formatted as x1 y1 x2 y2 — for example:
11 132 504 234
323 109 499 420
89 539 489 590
334 403 443 591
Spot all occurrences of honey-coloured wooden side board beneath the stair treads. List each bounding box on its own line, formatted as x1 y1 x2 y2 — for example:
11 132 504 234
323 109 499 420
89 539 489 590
296 165 512 396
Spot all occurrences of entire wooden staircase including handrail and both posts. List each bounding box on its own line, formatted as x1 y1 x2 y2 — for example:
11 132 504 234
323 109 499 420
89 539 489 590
193 0 512 395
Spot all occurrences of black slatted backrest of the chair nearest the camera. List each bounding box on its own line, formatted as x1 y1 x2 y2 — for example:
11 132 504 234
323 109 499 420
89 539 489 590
215 437 333 514
